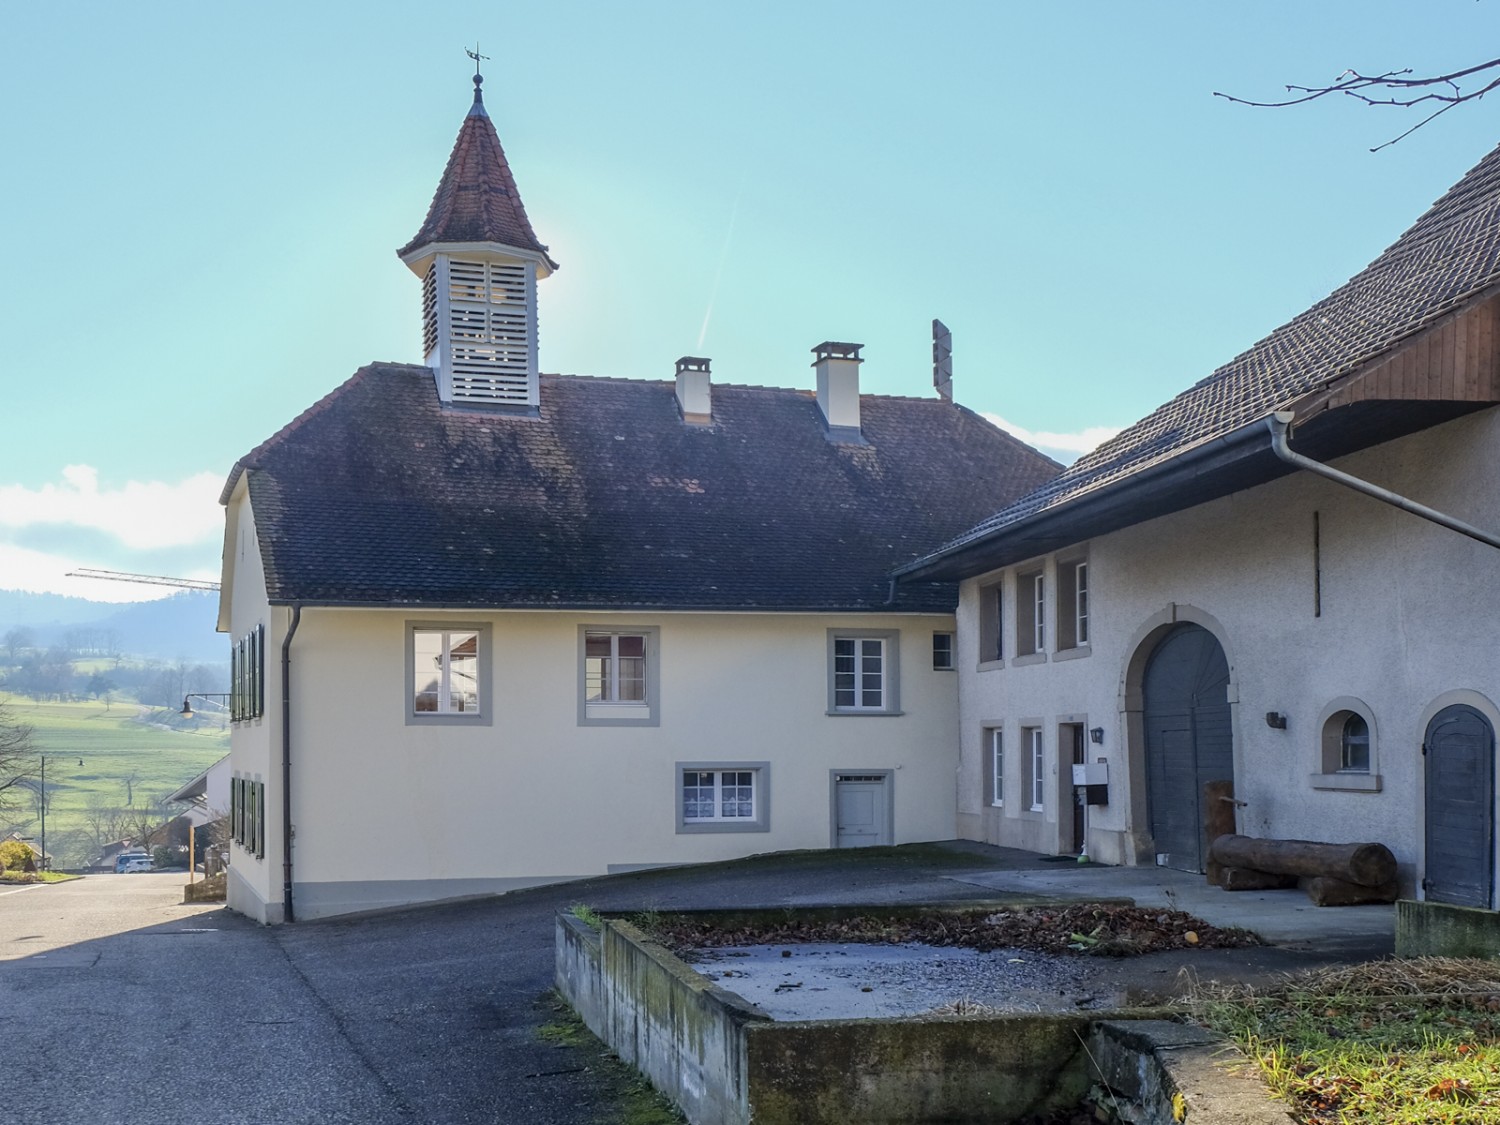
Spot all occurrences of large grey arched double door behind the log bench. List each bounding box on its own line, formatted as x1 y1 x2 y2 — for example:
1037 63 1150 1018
1142 624 1235 872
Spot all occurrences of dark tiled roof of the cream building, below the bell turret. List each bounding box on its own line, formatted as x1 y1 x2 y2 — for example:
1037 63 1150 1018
224 363 1059 612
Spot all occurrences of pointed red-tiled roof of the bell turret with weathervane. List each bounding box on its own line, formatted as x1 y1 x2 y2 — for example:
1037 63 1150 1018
398 74 558 270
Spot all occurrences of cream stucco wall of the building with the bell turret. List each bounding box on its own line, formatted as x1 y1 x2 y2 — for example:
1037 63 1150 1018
219 537 959 921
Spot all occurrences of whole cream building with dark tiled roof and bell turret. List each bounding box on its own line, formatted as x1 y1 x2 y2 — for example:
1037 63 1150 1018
219 75 1059 923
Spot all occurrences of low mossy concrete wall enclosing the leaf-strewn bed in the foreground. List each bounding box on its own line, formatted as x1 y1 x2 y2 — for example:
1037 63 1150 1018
557 915 1290 1125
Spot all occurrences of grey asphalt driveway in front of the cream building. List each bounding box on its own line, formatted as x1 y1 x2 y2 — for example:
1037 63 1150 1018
0 845 1392 1125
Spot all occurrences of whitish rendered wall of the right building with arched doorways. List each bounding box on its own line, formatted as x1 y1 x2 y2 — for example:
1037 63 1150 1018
959 410 1500 893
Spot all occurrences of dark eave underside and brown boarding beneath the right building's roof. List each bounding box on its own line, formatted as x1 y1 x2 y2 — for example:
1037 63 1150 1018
893 291 1500 582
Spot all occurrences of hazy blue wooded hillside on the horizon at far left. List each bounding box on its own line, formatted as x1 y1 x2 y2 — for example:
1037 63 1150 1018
0 590 230 663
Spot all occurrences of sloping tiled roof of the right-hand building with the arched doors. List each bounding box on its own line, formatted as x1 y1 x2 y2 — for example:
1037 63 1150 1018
902 141 1500 578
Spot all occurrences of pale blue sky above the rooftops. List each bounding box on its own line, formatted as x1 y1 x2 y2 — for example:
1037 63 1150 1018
0 0 1500 599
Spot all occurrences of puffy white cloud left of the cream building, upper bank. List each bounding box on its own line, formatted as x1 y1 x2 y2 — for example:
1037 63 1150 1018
0 465 224 552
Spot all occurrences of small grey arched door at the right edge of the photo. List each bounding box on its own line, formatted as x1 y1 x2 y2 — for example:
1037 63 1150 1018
1422 704 1496 909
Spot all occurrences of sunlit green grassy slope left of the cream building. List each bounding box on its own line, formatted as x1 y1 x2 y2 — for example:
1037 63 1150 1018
0 693 230 867
